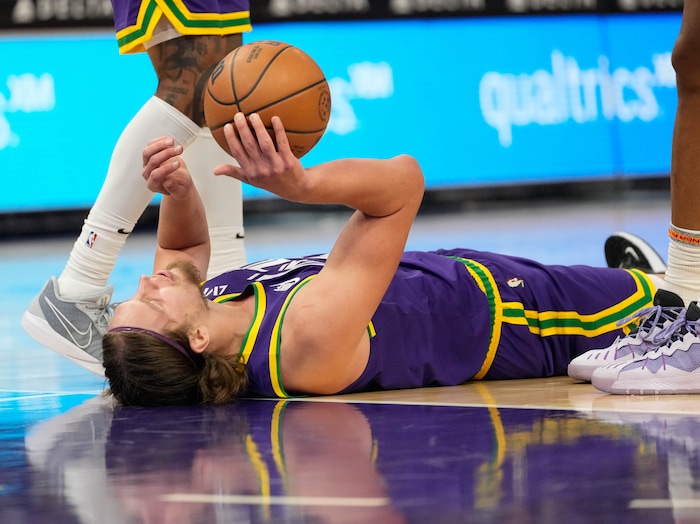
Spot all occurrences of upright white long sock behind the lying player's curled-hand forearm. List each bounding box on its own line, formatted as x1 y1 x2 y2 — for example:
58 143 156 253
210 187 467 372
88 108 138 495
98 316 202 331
182 128 246 278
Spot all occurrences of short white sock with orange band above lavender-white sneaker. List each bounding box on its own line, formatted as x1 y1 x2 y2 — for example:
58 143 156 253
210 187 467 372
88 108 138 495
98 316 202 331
663 224 700 304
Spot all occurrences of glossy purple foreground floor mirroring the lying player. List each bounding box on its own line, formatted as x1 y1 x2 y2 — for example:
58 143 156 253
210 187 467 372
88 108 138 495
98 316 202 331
9 398 700 524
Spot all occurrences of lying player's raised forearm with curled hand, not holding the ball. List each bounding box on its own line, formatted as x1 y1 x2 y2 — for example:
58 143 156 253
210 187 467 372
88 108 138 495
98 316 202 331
143 137 210 275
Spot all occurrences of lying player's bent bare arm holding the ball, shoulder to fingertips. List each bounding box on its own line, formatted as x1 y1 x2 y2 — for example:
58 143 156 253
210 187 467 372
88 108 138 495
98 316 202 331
215 114 424 393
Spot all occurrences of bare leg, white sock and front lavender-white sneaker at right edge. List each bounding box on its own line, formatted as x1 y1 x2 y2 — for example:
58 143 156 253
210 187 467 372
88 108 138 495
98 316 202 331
592 2 700 394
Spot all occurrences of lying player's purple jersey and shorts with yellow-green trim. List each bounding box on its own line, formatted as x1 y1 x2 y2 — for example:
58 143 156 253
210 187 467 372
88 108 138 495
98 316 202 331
204 249 655 397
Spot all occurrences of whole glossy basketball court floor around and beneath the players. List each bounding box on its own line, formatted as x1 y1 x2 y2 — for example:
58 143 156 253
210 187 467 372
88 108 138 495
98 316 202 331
0 191 700 524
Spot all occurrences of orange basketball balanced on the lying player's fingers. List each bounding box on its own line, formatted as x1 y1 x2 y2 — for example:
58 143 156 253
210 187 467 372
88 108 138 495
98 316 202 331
204 40 331 158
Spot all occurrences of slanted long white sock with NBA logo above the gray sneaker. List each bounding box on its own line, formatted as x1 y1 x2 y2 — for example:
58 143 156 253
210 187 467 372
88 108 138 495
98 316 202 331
58 96 200 300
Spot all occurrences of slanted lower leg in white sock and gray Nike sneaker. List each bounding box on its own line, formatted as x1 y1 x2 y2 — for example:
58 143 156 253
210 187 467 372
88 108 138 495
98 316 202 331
22 97 199 374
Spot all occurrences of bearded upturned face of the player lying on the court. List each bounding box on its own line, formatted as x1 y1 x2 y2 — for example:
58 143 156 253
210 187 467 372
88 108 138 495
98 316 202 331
109 262 209 332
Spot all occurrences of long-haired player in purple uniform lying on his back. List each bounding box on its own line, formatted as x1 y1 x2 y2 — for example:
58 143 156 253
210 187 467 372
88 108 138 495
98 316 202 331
104 113 655 406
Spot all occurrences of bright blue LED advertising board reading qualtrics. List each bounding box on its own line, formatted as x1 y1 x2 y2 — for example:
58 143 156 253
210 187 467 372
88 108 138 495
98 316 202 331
0 13 680 212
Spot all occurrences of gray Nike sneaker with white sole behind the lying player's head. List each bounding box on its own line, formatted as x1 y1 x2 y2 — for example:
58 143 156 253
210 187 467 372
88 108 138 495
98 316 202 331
22 277 114 377
